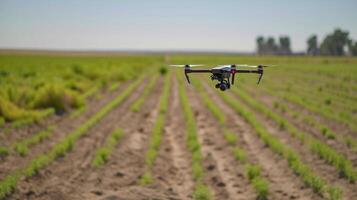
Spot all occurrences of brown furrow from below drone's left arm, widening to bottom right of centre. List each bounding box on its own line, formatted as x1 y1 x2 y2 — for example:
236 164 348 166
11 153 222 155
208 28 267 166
187 85 256 199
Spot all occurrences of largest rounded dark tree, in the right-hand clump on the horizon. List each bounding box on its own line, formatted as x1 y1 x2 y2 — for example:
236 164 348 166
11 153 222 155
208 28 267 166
320 29 349 56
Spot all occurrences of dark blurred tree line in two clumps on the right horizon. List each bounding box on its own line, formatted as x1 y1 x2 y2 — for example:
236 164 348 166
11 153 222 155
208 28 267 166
256 29 357 56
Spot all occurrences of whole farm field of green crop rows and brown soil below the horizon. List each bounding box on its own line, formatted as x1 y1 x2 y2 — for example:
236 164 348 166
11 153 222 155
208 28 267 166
0 54 357 200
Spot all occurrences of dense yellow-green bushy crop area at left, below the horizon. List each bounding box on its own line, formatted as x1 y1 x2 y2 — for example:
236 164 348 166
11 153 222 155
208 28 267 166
0 55 161 127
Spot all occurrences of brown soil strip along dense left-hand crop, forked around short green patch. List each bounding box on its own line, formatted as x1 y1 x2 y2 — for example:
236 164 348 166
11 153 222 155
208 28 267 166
0 83 135 179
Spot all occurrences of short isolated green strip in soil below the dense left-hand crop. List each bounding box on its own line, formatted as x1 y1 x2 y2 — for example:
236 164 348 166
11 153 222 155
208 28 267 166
13 126 55 156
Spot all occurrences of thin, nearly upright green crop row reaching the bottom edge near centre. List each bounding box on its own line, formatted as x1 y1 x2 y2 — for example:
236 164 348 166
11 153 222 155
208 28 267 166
178 73 212 200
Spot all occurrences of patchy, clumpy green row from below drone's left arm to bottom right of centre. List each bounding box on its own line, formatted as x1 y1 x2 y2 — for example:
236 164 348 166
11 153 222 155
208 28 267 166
192 80 269 200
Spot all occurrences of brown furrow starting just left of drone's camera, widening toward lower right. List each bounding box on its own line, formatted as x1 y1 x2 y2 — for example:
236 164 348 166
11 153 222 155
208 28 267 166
203 81 321 199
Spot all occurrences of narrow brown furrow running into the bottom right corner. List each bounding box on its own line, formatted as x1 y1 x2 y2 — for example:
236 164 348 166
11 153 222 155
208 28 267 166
232 89 357 199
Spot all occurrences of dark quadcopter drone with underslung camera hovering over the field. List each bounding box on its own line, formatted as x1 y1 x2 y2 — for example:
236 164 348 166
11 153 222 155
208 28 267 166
170 64 273 91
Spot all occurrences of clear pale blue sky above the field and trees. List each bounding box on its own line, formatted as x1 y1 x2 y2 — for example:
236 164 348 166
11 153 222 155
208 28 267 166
0 0 357 52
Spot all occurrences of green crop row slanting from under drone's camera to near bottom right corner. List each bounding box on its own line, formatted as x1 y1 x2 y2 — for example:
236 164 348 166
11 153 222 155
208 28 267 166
213 86 342 200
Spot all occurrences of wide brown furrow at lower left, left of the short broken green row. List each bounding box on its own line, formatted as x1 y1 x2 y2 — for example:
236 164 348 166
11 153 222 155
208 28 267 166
12 78 158 199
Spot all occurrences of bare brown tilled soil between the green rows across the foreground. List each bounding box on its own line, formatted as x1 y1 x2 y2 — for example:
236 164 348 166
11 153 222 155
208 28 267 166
0 74 357 200
